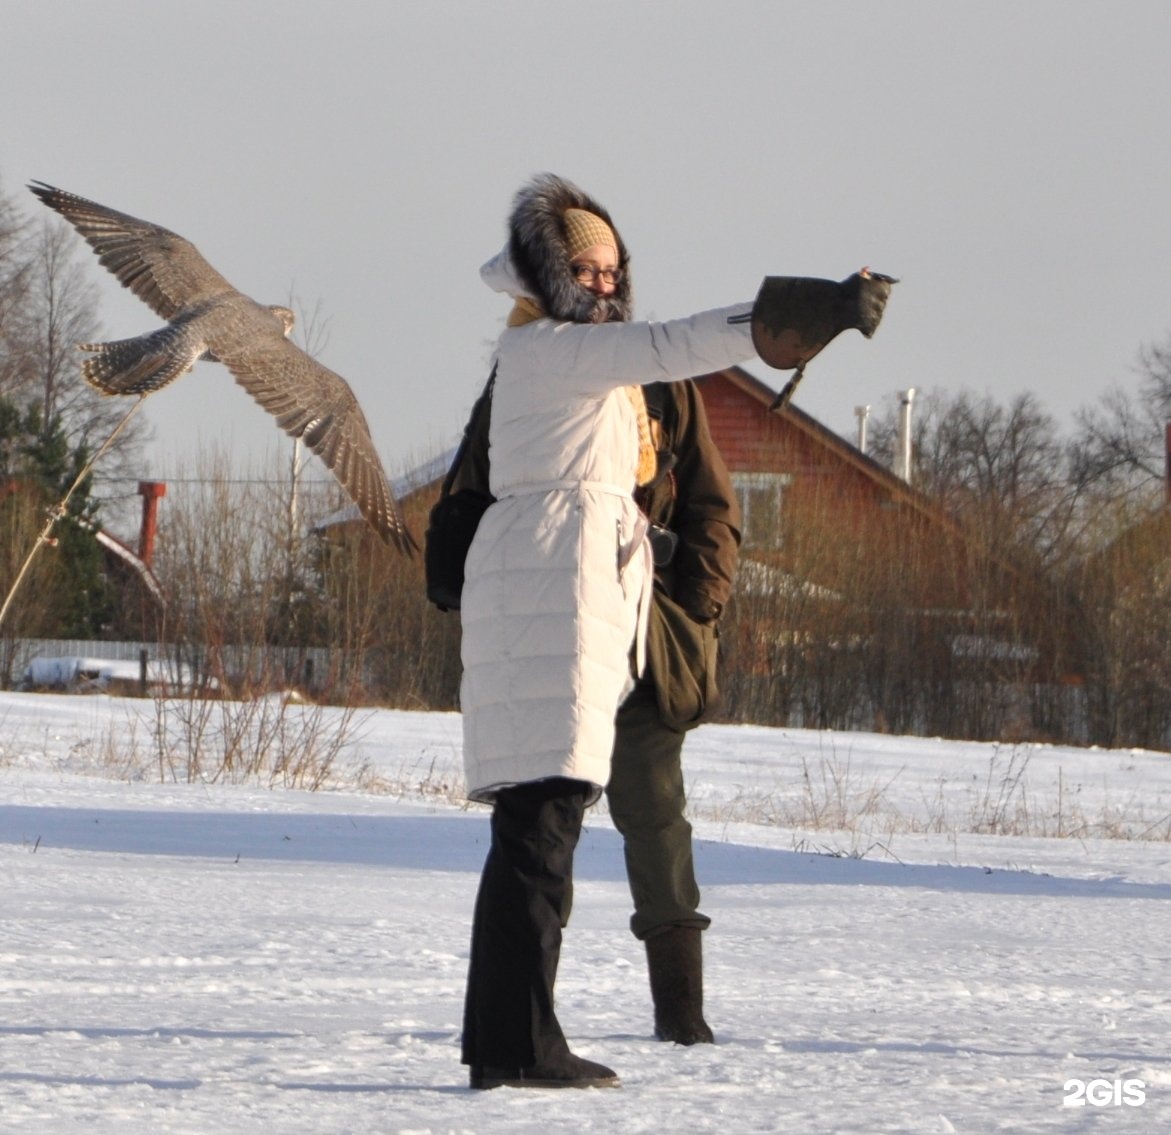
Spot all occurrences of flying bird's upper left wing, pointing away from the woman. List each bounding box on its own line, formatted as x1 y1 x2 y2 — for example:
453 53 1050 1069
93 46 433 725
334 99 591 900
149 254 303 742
28 182 235 321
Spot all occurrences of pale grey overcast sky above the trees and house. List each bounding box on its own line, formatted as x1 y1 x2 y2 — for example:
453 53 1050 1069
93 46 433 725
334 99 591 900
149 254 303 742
0 0 1171 503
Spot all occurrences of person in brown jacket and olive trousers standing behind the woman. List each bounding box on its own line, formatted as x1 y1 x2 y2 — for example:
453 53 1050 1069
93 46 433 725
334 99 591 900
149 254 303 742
605 382 740 1045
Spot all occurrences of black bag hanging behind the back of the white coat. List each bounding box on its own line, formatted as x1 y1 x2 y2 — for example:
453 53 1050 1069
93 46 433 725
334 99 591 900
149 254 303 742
423 367 497 611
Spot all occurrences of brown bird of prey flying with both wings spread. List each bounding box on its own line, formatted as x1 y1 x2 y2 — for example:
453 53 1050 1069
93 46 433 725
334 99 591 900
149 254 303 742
28 182 417 554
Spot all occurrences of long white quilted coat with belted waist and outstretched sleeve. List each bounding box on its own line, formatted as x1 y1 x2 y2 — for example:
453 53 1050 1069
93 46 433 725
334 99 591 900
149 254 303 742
460 253 753 800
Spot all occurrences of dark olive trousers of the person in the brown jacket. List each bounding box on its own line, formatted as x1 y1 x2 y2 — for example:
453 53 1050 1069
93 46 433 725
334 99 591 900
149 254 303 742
605 682 711 939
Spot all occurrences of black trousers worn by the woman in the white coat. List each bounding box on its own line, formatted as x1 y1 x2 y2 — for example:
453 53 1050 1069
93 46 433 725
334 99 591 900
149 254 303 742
463 777 589 1068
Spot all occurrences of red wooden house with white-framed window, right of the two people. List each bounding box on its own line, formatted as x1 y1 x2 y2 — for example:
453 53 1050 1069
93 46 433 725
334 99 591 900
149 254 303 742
679 367 1059 737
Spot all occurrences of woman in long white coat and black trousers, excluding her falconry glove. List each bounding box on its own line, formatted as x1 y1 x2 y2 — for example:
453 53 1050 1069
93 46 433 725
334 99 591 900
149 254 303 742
460 175 754 1087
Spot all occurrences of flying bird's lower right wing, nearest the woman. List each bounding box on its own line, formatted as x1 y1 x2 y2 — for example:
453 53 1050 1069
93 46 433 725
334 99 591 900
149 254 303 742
218 336 418 554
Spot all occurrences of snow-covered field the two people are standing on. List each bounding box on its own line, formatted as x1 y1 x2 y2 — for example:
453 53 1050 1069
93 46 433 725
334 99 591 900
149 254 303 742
0 693 1171 1135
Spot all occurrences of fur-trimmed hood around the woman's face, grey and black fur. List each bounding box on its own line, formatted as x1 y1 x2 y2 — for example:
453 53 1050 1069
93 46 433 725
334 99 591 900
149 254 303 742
480 173 634 323
